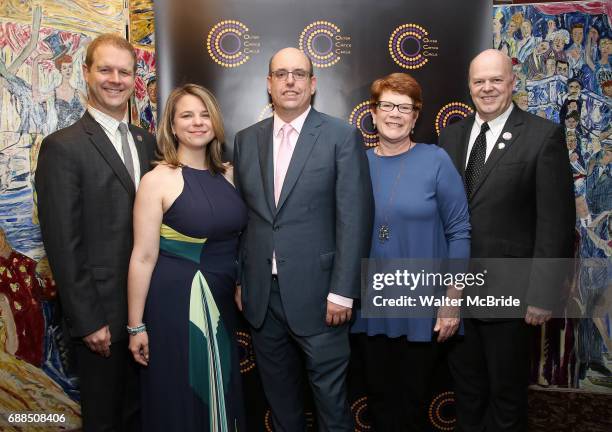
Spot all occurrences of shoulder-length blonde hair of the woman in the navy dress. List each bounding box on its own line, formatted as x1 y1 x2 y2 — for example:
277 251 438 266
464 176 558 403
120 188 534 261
157 84 226 174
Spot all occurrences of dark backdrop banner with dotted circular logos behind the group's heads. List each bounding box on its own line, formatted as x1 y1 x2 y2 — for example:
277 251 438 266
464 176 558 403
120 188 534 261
155 0 492 148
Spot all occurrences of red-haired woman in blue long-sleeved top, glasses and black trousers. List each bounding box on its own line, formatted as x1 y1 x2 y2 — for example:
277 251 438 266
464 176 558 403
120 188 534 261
352 73 470 432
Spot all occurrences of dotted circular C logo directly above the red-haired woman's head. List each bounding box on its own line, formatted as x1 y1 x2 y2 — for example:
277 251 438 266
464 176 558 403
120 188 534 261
389 24 429 69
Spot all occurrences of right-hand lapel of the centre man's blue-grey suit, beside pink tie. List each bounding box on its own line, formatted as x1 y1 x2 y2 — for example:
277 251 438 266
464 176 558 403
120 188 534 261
276 108 322 212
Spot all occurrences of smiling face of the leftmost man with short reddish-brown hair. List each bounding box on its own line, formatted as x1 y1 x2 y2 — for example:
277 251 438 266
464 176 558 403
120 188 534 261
83 44 134 120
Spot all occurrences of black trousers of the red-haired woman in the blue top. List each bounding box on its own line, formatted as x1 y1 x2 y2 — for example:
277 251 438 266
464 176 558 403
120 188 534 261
354 334 446 432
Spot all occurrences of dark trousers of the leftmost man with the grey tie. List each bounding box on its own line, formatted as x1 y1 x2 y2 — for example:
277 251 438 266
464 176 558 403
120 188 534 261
73 339 141 432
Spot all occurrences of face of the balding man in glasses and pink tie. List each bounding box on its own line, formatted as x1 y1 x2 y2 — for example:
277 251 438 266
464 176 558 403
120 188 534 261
268 48 317 122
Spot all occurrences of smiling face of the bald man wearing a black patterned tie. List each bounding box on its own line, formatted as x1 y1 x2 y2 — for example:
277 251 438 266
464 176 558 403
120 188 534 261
469 49 516 121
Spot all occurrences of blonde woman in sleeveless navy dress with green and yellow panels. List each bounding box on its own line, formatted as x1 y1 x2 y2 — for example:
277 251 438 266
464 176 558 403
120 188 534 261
128 84 247 432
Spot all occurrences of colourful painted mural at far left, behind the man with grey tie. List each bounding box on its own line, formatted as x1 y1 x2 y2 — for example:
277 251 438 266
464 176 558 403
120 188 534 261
0 0 125 431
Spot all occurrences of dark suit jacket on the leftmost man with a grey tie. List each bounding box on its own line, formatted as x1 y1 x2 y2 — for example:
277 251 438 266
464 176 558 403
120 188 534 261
36 112 155 341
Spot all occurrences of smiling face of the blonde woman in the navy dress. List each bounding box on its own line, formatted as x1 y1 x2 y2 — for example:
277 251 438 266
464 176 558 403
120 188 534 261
172 94 215 148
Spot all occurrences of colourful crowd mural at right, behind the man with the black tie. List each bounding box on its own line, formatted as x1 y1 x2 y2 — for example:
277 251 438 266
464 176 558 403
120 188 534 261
493 1 612 392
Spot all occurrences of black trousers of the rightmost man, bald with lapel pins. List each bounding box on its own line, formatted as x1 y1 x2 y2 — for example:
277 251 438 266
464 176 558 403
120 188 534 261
449 319 531 432
